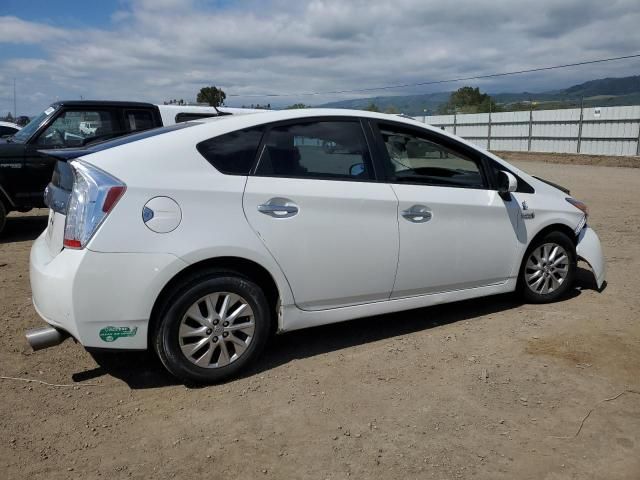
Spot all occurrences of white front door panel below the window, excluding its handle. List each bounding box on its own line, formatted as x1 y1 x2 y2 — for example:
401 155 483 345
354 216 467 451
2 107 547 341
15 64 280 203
392 185 519 298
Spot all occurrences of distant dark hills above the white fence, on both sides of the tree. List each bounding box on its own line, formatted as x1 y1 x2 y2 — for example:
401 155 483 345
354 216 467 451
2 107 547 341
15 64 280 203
319 75 640 116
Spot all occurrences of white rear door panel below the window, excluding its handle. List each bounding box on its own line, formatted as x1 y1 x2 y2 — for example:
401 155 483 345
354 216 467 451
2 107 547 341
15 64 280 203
244 177 399 310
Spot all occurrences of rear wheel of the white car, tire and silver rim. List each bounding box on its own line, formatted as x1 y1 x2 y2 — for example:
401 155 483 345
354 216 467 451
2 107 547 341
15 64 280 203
155 271 271 383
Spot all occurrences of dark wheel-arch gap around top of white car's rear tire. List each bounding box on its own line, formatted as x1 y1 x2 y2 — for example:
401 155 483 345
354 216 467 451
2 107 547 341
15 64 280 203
147 256 281 345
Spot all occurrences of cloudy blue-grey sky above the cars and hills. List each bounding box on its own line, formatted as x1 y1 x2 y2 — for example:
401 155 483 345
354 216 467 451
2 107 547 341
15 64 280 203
0 0 640 114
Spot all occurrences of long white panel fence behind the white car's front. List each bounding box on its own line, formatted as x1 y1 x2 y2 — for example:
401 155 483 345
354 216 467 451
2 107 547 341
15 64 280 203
415 105 640 155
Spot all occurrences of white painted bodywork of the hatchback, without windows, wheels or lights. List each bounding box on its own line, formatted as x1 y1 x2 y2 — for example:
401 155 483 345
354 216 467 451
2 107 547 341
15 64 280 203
26 109 605 349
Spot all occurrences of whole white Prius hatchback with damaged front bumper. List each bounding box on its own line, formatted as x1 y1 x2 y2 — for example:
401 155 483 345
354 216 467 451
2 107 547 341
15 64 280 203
27 110 605 382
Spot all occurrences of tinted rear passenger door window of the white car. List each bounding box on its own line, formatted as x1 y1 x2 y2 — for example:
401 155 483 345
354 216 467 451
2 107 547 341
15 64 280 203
256 120 373 180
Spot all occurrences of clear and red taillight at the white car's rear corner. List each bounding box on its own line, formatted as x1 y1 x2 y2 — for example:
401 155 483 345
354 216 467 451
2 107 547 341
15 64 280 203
64 161 127 248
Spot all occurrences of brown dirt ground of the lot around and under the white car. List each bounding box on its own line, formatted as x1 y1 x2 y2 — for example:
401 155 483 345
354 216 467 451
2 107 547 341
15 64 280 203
0 156 640 480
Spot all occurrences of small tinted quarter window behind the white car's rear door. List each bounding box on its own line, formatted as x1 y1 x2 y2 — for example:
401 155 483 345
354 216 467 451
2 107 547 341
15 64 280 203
196 127 264 175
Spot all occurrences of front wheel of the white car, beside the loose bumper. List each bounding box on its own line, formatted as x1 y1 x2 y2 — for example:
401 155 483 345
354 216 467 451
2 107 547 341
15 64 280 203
518 232 576 303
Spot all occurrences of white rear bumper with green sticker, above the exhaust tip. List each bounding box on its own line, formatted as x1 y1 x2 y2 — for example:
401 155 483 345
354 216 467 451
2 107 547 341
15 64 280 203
30 234 187 350
